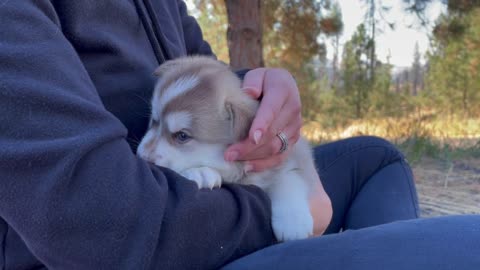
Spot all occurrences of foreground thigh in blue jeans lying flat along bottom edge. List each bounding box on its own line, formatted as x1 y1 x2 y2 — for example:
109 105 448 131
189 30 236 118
223 215 480 270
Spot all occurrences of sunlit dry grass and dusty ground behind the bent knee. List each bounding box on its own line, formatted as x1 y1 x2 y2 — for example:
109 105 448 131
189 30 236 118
302 113 480 217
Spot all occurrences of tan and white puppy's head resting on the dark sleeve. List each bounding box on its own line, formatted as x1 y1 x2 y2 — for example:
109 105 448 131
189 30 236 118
137 56 258 171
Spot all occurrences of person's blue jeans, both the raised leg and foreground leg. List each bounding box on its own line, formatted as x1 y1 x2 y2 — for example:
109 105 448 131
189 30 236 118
224 137 480 270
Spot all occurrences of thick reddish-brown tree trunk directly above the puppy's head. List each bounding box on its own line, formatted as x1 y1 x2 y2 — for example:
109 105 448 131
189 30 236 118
225 0 264 69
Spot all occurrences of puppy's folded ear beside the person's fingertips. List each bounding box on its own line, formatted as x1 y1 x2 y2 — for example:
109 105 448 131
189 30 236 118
225 102 256 143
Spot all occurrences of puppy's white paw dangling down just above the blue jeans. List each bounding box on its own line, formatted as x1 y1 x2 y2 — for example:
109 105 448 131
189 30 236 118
272 207 313 241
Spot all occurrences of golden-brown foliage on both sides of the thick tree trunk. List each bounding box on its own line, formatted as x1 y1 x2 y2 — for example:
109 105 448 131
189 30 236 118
189 0 336 123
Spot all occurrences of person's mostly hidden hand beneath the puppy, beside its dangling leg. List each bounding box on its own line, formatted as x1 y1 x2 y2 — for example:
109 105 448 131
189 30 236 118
309 175 333 236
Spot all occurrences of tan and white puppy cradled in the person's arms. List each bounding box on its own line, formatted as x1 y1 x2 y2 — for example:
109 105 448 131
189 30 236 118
137 56 318 241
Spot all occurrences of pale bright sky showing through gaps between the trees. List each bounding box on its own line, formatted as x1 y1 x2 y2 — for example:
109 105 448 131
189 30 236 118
186 0 444 67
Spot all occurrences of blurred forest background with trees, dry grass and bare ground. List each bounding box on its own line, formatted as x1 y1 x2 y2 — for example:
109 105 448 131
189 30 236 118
190 0 480 216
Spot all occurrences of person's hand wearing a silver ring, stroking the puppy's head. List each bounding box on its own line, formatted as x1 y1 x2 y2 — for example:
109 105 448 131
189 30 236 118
225 68 302 172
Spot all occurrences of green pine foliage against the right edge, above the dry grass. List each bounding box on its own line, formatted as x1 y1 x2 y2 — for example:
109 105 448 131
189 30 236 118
425 8 480 116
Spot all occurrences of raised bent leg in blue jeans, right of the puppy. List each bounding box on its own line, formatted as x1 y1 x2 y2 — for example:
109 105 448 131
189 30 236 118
315 136 418 234
